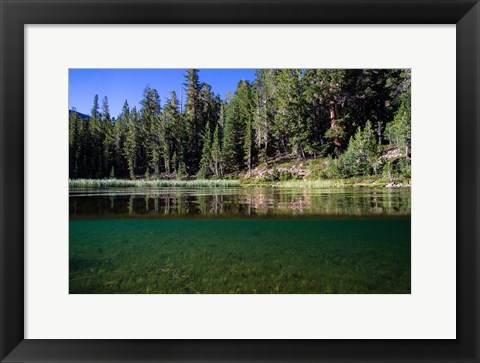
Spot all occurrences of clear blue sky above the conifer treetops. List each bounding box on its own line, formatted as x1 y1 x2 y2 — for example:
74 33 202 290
68 69 255 117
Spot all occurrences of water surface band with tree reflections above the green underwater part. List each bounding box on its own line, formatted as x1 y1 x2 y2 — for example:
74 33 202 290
70 188 411 216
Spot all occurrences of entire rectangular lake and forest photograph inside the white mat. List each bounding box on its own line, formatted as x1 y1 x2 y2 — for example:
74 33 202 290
66 69 414 294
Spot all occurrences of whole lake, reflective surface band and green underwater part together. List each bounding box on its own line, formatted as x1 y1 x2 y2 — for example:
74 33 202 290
70 188 411 294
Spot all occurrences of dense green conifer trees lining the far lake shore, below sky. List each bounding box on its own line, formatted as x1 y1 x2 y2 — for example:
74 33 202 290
69 69 411 179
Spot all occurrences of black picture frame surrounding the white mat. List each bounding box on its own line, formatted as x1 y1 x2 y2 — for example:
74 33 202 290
0 0 480 362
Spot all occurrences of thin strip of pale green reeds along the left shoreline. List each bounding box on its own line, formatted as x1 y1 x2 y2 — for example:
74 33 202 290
68 179 240 188
